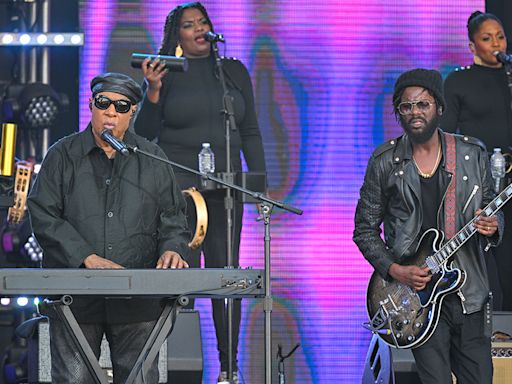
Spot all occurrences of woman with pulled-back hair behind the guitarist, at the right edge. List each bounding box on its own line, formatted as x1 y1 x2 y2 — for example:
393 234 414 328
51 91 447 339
441 11 512 310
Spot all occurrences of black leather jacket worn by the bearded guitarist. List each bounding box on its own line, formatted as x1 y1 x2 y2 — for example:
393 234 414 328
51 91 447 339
353 130 504 313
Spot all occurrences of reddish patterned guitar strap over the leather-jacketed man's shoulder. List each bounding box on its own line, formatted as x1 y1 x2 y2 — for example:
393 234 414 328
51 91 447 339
444 133 457 239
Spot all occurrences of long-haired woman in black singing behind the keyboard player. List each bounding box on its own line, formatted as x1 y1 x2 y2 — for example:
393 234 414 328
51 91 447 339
135 2 265 383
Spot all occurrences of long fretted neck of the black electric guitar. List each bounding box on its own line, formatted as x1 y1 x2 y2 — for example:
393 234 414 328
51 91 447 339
427 184 512 269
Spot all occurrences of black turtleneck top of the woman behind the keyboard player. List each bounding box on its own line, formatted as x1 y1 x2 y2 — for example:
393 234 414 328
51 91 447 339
135 57 265 188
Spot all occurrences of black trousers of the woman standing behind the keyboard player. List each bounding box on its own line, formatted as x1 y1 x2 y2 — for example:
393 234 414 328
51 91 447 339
187 190 243 371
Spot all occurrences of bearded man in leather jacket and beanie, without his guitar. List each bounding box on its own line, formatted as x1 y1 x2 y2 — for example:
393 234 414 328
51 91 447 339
354 69 503 384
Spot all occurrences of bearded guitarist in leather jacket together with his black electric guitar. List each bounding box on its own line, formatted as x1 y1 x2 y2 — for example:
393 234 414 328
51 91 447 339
354 69 502 384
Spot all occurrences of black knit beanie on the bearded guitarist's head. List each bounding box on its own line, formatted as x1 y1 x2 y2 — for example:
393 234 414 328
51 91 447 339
393 68 446 111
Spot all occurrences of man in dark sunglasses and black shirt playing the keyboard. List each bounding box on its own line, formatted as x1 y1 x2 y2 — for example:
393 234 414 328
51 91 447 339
28 73 189 383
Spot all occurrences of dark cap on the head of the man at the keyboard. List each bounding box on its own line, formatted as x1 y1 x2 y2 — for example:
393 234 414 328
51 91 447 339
91 72 142 104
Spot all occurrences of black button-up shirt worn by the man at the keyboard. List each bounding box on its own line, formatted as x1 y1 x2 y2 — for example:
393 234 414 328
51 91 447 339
28 126 190 323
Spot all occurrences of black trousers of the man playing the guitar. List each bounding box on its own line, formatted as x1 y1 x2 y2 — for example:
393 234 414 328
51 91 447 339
412 294 493 384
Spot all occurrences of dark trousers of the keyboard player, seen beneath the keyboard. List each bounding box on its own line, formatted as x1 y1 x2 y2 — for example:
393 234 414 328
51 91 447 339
50 319 159 384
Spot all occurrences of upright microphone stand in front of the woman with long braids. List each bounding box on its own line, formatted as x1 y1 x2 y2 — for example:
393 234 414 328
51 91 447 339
211 41 237 383
